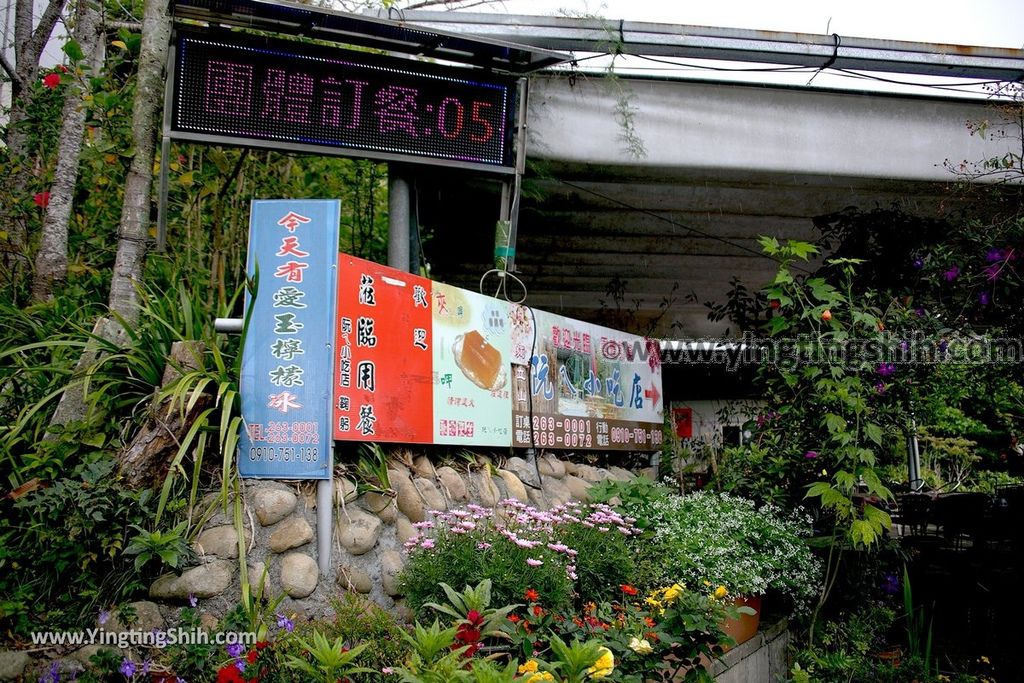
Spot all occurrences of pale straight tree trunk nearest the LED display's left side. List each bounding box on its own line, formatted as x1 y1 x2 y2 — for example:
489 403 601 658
108 0 171 325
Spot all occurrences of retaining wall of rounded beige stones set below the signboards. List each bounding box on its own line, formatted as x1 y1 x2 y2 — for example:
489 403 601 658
150 455 635 620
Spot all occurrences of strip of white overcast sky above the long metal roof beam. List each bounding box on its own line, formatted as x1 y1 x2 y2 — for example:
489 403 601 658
479 0 1024 48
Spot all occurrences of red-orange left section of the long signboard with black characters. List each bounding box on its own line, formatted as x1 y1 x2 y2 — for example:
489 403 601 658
334 254 434 443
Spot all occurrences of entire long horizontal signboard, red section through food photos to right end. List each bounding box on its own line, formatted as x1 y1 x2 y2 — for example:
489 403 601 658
333 254 663 451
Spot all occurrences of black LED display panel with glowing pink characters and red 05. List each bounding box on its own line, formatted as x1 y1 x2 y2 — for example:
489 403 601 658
171 33 515 170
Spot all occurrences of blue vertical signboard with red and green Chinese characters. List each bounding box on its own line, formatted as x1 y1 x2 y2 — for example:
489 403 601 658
239 200 341 479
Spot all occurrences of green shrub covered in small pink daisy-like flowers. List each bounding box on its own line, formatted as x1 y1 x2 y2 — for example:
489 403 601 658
401 500 639 610
